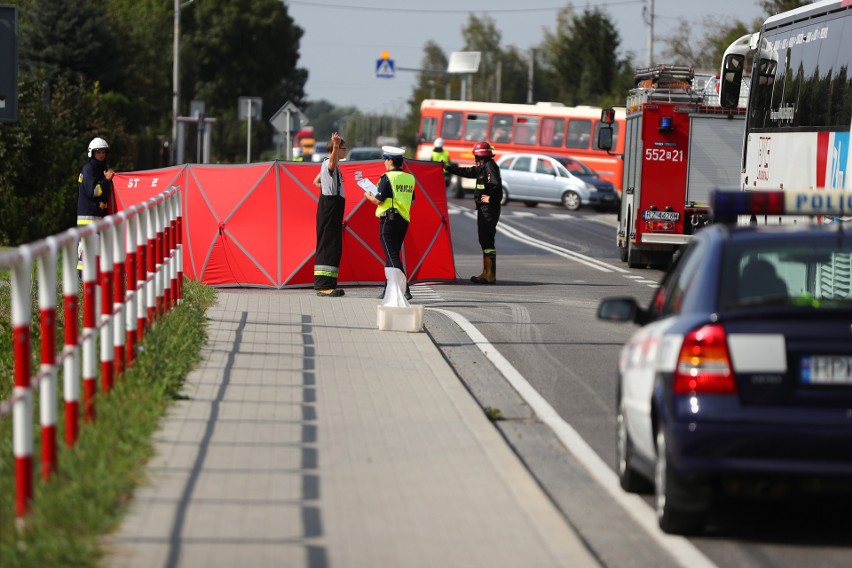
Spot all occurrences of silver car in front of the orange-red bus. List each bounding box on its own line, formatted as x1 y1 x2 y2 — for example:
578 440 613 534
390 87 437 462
497 154 611 211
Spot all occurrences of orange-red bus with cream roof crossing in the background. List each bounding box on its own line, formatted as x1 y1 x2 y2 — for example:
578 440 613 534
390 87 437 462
416 99 625 194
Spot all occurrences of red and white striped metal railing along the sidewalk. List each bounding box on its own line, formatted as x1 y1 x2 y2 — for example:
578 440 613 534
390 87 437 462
0 187 183 518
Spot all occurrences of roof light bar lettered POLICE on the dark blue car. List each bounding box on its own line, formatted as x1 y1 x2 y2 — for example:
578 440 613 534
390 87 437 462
710 189 852 221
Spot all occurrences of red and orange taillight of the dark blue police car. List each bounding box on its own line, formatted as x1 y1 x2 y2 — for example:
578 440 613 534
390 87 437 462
672 324 737 394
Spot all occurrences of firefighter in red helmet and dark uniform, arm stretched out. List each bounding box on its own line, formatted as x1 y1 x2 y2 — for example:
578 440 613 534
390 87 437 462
447 142 503 284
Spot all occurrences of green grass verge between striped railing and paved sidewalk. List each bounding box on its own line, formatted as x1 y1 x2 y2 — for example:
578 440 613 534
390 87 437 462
0 282 215 568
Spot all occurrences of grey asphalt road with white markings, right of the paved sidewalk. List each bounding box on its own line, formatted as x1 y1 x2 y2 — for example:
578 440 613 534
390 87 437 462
427 199 852 567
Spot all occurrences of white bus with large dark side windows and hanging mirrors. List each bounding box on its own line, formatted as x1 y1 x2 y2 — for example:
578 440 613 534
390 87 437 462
721 0 852 200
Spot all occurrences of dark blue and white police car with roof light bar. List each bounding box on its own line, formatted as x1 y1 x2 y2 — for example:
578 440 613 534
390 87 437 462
598 191 852 534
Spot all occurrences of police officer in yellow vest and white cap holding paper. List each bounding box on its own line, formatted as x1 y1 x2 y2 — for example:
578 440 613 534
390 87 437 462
364 146 415 300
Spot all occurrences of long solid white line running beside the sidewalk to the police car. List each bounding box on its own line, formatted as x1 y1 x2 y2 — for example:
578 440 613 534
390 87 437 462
427 308 716 568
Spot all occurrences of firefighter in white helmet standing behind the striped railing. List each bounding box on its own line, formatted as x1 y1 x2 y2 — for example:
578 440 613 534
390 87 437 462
77 138 115 276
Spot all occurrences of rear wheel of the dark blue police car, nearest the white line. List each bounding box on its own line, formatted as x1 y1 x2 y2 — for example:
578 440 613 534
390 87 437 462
654 427 705 535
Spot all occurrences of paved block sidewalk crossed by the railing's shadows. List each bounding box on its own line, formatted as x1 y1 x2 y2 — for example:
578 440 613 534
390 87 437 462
105 289 598 568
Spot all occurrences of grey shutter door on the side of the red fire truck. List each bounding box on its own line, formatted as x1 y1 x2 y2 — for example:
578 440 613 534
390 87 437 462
686 115 745 207
